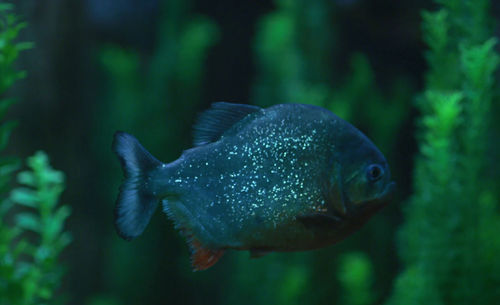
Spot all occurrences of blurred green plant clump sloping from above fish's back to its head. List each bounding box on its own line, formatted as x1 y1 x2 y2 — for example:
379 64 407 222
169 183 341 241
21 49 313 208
252 0 413 152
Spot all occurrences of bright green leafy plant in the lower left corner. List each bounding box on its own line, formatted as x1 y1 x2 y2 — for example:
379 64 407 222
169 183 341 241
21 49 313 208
0 151 71 304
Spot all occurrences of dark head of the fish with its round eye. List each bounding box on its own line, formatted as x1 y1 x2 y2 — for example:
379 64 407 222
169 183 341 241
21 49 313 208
334 127 395 216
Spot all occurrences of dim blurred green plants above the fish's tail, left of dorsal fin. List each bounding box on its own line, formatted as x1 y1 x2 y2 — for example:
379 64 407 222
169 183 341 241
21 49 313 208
96 0 219 154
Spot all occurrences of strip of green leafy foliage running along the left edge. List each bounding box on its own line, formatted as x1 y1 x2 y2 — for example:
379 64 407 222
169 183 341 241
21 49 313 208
0 4 71 305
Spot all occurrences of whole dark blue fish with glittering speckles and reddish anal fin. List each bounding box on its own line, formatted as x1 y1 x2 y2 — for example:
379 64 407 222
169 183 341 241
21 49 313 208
112 102 395 271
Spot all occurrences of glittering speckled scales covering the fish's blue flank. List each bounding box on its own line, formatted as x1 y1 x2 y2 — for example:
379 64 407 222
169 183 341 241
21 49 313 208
159 104 329 248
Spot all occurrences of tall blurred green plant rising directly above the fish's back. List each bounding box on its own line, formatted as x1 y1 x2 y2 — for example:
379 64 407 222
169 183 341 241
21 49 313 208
252 0 336 106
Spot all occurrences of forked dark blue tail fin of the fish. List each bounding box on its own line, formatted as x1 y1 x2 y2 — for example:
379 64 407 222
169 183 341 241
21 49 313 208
113 132 162 240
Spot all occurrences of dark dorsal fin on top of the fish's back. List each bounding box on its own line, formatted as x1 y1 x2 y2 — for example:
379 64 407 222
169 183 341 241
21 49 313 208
193 102 262 146
